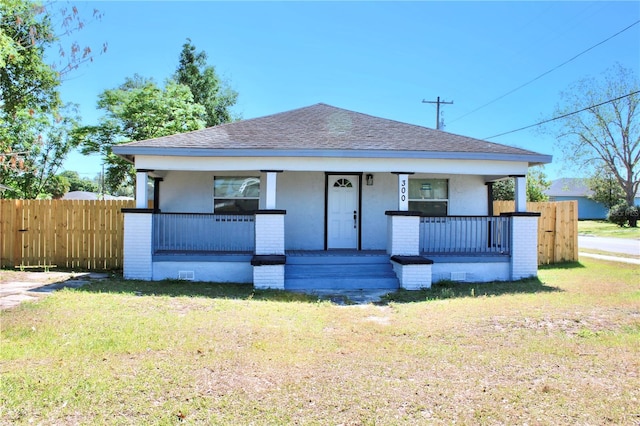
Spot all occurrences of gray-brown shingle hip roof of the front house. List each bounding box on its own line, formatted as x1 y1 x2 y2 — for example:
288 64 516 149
114 103 552 161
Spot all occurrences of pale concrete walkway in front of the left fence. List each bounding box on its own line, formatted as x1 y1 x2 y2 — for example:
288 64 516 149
0 272 109 309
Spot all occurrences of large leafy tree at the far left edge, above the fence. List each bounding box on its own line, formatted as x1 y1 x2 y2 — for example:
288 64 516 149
0 0 106 198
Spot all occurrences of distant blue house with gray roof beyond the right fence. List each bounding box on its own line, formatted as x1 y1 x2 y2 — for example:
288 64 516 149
545 178 640 220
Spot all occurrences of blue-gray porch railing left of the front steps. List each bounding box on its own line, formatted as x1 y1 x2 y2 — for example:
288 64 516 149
153 213 255 253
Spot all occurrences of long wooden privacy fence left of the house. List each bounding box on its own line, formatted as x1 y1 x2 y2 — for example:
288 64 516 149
0 200 135 270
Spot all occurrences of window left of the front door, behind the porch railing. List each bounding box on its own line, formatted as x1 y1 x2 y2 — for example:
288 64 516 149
213 176 260 213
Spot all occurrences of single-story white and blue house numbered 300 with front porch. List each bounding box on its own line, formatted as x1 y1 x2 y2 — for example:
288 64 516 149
113 104 551 290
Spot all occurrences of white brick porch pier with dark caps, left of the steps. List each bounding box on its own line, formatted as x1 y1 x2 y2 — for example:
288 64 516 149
251 210 287 289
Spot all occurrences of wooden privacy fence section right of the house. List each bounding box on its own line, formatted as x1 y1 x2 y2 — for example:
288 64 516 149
493 201 578 265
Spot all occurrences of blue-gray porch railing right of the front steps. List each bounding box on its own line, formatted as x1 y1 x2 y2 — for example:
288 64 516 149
420 216 511 255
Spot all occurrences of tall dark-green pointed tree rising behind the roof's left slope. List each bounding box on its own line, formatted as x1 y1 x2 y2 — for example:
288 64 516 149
174 39 238 127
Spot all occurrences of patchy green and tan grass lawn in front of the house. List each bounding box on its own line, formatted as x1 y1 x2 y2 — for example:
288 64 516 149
0 259 640 425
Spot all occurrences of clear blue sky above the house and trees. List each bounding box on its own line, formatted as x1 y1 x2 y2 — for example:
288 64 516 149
56 1 640 179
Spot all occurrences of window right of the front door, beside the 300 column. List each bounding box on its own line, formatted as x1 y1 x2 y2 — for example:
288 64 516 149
409 178 449 216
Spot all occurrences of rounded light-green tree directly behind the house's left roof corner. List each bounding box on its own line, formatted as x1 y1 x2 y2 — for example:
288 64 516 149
75 75 205 193
